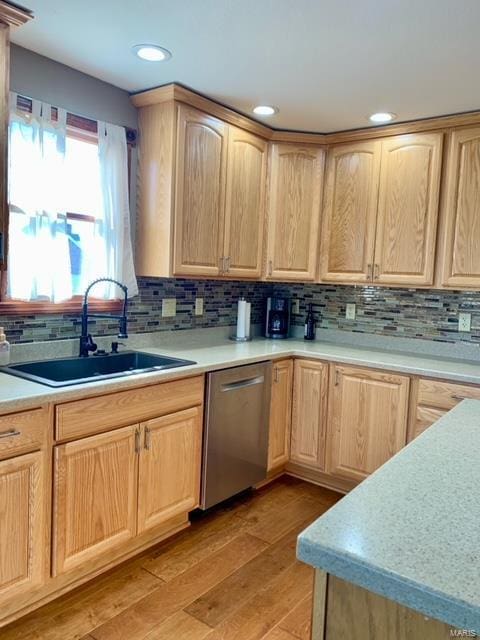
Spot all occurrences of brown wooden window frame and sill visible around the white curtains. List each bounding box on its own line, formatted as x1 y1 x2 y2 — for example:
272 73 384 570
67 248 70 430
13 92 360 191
0 95 136 316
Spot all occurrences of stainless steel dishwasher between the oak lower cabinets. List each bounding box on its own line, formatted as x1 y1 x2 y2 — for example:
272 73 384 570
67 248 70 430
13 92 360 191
200 362 272 509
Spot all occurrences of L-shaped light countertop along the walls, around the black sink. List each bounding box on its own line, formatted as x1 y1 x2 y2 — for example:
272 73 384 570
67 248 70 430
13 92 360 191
0 330 480 413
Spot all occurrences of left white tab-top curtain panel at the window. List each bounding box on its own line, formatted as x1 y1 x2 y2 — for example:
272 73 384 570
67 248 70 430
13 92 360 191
7 94 72 302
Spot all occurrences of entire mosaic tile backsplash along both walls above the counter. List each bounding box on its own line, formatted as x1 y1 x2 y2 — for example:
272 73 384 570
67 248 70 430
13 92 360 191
0 278 480 343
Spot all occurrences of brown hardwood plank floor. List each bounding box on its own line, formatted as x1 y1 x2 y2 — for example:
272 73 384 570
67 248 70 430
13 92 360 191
0 476 341 640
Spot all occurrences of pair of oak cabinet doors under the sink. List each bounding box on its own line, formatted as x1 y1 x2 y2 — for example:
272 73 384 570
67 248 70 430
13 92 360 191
53 407 202 575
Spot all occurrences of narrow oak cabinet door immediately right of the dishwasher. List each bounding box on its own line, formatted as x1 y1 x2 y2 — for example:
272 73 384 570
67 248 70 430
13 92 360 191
268 360 293 471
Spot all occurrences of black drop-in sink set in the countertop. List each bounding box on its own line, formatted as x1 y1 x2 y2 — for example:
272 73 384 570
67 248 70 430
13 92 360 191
0 351 196 387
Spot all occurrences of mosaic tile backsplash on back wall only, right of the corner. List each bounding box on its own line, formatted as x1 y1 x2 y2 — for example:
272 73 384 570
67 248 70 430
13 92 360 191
274 284 480 343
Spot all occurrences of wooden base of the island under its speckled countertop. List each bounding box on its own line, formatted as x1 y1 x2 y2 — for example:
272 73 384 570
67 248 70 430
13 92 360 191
312 569 454 640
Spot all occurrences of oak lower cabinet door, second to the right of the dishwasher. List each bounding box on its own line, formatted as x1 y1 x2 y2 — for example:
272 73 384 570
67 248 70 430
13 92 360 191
290 360 328 471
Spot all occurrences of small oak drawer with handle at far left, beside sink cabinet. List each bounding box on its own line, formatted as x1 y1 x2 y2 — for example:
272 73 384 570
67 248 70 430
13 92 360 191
0 409 49 458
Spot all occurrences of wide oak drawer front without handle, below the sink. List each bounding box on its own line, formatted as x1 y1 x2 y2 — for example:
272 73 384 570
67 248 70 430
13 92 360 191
55 376 203 440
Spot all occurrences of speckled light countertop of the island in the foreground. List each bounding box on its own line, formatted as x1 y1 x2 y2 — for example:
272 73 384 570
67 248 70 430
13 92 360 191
297 400 480 633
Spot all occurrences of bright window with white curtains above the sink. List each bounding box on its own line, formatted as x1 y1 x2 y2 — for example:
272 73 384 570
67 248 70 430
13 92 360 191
0 98 137 313
